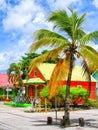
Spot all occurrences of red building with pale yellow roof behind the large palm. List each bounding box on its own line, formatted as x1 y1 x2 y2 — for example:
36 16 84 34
24 63 96 100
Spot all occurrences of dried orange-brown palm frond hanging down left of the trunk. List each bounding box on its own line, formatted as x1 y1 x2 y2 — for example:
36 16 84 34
48 59 69 99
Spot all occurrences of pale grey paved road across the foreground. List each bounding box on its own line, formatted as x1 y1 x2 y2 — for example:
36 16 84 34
0 102 98 130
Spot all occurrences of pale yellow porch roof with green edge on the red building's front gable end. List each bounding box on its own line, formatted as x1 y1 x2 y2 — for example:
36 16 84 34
23 78 45 84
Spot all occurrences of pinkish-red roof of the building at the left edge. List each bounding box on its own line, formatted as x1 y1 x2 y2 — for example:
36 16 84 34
0 74 12 88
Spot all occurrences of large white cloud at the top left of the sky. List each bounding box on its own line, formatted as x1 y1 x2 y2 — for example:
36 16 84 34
3 0 41 30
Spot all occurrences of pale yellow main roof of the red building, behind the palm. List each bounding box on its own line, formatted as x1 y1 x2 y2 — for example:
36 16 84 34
37 63 96 82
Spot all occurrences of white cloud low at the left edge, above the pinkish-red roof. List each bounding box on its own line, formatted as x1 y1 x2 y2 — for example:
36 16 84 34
0 39 30 70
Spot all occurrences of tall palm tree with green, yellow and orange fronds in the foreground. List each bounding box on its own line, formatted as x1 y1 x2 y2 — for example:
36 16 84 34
30 8 98 125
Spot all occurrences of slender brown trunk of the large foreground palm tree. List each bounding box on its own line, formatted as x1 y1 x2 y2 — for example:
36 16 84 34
64 55 73 126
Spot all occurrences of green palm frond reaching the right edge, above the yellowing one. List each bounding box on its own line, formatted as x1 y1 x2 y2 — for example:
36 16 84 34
80 31 98 44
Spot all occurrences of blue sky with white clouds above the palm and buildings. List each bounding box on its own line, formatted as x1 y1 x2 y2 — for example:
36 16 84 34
0 0 98 72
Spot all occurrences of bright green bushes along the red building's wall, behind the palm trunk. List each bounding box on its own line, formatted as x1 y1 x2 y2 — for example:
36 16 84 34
40 86 88 107
